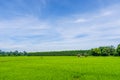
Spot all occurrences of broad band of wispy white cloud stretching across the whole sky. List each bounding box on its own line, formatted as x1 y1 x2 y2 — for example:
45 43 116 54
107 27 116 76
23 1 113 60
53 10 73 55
0 0 120 51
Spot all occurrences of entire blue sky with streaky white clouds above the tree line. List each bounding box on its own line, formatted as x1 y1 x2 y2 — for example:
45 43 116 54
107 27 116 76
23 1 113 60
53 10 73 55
0 0 120 51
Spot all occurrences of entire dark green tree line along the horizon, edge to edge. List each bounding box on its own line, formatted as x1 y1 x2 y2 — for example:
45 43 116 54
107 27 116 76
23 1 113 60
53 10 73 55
0 44 120 56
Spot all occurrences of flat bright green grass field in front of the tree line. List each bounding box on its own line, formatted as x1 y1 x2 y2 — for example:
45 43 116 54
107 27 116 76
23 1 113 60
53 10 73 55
0 56 120 80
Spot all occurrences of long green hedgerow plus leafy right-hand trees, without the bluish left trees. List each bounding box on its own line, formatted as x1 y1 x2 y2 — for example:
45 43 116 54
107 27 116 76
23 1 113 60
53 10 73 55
28 45 120 56
